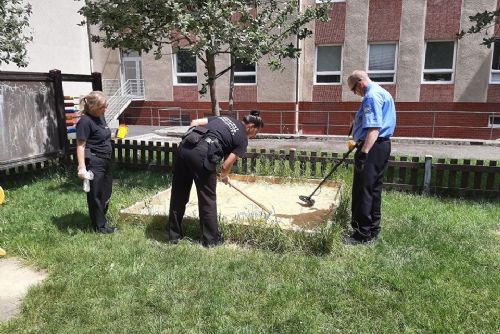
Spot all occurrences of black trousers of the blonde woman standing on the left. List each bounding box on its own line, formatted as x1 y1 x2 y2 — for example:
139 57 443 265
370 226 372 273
86 155 113 230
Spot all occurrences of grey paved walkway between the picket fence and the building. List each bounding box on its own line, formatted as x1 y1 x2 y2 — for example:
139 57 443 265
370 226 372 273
126 125 500 160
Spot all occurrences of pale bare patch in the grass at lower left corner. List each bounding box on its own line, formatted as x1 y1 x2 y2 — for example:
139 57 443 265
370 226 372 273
0 258 47 321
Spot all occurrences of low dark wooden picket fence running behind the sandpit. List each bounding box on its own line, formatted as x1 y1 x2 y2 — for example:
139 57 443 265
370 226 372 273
0 140 500 198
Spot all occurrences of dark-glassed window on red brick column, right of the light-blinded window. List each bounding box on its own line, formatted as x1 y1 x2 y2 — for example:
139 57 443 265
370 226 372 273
423 42 455 83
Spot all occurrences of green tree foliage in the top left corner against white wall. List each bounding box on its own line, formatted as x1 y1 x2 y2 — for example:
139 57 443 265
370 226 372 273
0 0 33 67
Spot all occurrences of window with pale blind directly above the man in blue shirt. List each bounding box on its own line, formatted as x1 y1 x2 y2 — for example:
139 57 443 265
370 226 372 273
367 44 396 83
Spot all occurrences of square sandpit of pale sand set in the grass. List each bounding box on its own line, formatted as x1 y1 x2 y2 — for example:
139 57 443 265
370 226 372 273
120 175 341 230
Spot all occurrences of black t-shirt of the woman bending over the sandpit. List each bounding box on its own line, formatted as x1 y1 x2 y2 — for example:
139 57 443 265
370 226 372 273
206 116 248 157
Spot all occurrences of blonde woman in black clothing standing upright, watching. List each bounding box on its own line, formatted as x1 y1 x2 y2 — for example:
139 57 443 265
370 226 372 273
76 91 117 234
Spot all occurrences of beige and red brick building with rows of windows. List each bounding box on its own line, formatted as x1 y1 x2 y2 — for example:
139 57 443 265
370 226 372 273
92 0 500 139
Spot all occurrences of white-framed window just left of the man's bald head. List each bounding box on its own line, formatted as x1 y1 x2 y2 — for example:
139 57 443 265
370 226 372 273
315 45 342 84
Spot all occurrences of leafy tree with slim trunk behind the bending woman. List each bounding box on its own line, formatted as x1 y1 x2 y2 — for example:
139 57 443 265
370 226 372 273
80 0 328 114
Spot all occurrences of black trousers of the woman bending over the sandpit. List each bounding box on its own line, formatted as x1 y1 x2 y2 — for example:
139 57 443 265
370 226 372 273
168 140 222 246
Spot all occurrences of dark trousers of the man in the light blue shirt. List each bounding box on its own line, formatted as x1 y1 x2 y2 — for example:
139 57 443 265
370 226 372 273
351 140 391 241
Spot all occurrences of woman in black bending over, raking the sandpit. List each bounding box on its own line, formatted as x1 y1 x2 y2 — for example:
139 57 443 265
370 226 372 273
169 110 264 247
